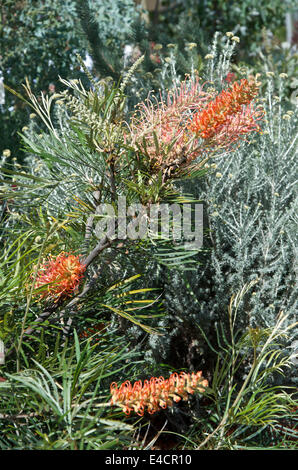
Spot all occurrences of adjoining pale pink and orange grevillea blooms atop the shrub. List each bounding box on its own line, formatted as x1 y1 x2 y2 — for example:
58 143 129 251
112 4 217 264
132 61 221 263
127 77 263 180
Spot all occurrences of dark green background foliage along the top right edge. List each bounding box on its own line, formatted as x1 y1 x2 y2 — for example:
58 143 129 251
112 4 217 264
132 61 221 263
146 0 295 61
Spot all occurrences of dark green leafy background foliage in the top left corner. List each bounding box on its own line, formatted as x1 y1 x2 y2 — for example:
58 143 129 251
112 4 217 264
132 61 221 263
0 0 85 160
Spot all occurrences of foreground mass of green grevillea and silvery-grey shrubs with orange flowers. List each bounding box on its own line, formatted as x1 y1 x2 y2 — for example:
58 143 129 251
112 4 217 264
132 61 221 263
0 11 297 450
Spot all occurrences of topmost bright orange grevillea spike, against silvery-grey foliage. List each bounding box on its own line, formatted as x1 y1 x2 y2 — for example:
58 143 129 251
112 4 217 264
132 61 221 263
188 79 261 140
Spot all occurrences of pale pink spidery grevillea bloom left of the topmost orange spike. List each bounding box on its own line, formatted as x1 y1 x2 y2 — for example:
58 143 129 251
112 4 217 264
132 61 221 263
127 78 212 173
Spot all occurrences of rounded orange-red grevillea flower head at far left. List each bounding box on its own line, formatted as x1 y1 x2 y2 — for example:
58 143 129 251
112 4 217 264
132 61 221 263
34 252 86 302
